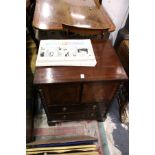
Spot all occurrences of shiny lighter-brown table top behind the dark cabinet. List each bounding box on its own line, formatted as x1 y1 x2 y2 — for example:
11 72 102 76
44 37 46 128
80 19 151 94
33 0 115 32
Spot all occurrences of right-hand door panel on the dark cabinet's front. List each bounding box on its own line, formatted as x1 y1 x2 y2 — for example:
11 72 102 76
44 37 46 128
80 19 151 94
82 81 119 103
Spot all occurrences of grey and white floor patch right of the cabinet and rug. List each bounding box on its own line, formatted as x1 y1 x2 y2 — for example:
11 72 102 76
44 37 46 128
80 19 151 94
104 100 129 155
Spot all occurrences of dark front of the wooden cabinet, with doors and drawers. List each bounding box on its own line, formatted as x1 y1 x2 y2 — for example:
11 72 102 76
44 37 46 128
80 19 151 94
38 81 120 125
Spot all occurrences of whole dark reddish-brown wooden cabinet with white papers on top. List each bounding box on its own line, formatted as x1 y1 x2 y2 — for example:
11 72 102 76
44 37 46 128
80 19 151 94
34 40 127 125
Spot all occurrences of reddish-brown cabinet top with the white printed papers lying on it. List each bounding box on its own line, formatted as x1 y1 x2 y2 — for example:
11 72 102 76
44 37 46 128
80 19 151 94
34 40 128 84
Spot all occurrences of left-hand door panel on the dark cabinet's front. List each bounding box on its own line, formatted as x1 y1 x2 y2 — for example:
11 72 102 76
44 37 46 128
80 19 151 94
41 83 80 105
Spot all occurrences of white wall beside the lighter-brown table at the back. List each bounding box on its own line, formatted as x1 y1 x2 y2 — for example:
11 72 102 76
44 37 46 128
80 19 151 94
102 0 129 44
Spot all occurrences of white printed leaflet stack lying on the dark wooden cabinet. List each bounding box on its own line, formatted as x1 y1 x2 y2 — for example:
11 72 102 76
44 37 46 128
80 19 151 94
36 39 96 66
